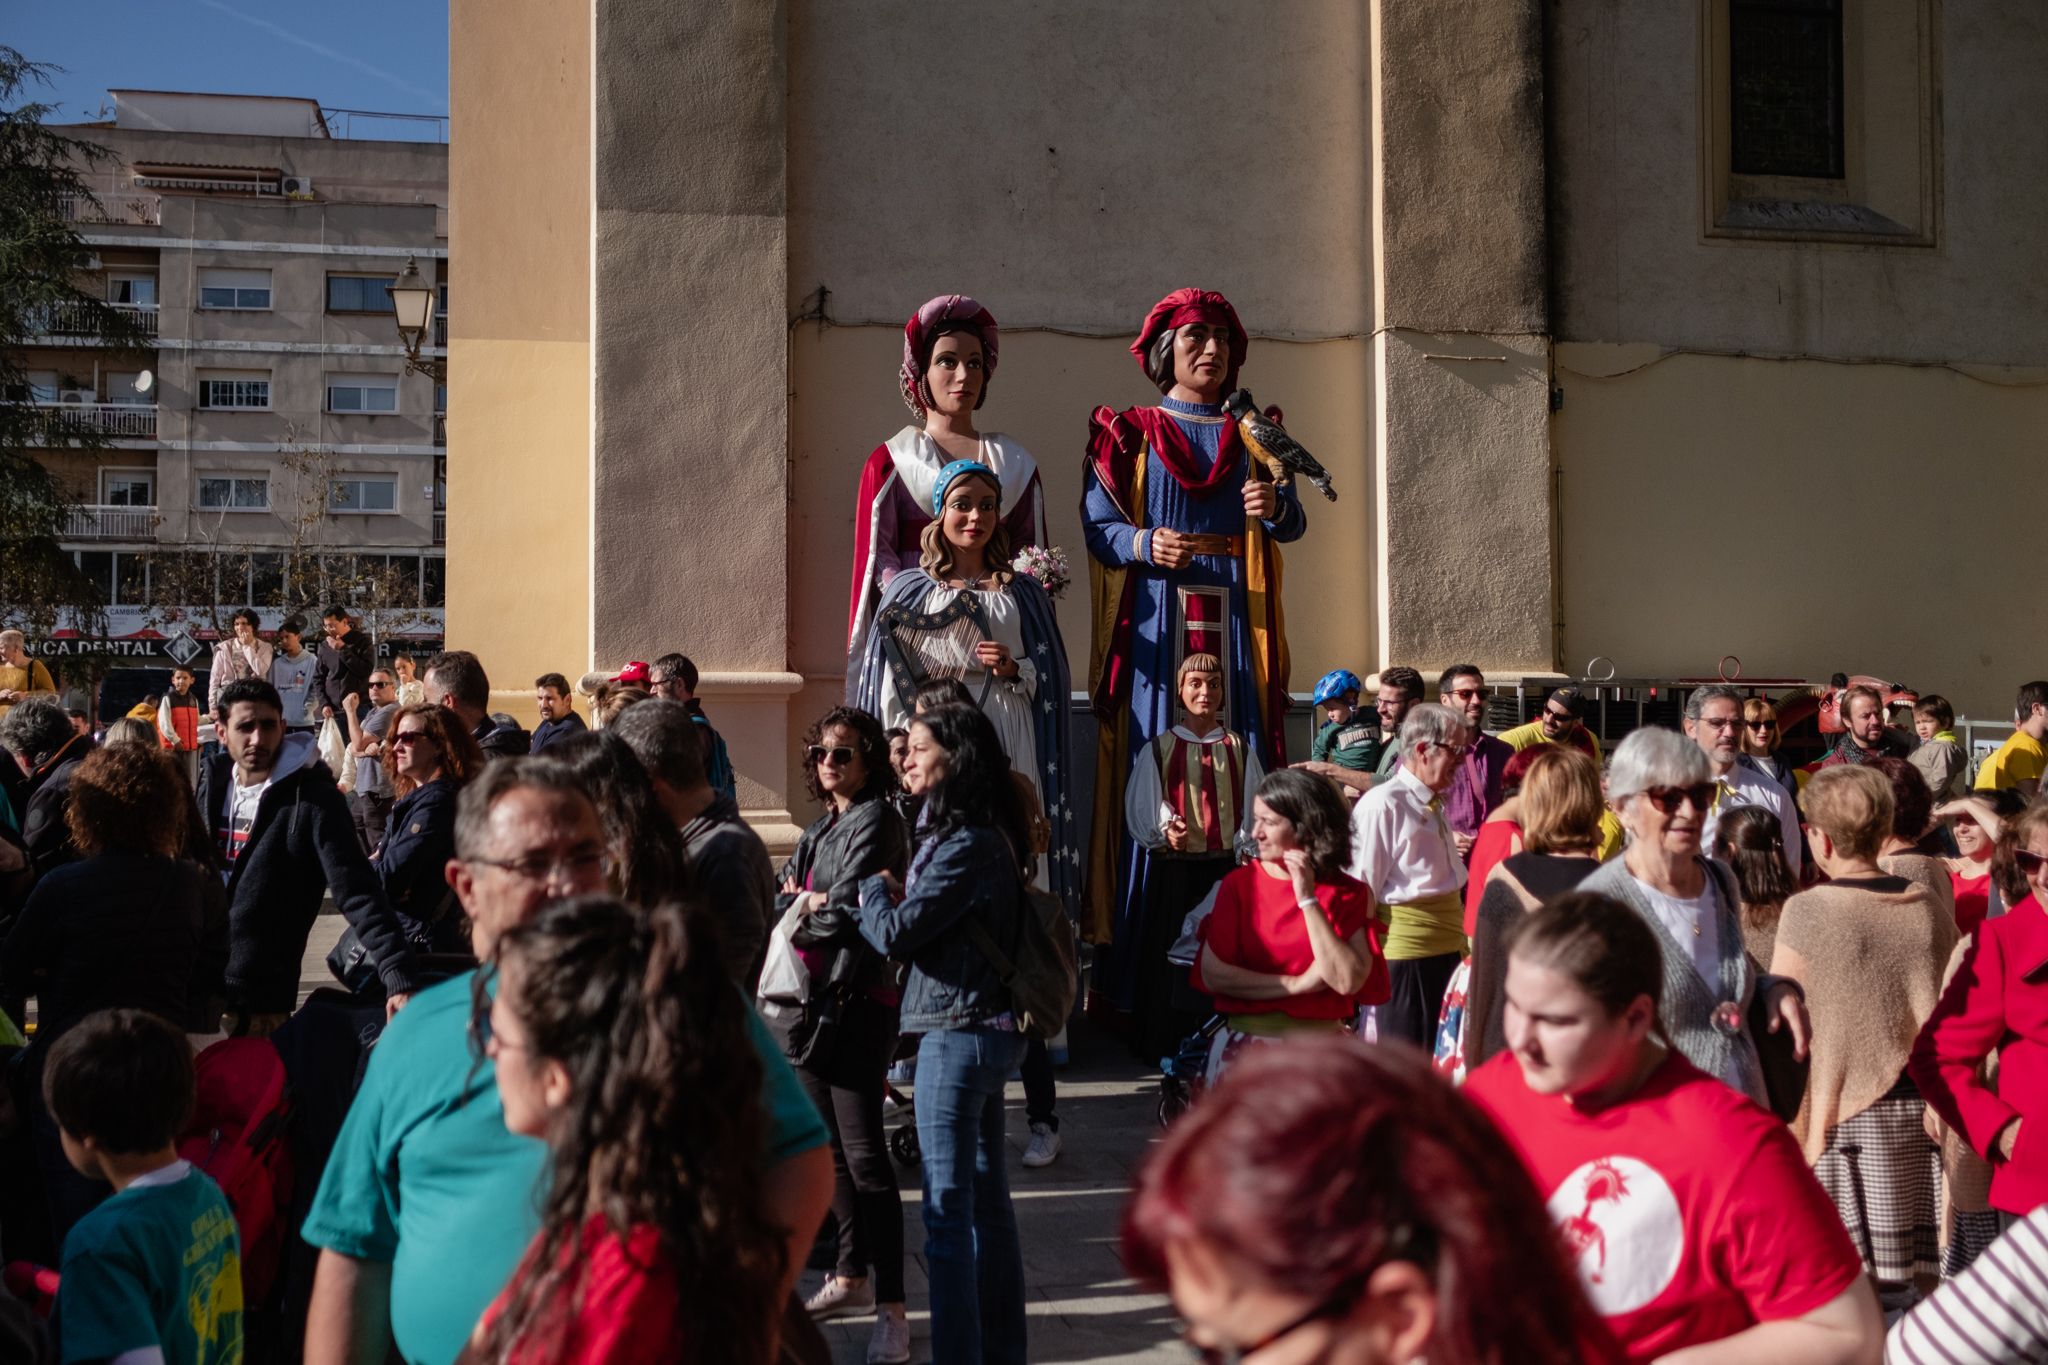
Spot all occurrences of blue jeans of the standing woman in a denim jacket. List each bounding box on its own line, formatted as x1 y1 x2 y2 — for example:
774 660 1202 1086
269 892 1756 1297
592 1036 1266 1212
915 1029 1024 1365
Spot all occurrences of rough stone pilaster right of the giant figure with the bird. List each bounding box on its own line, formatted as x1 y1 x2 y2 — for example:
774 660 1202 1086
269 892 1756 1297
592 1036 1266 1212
1372 0 1554 671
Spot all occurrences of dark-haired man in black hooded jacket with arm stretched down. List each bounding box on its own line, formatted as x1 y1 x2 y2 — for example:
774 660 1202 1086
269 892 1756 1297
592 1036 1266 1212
199 677 422 1036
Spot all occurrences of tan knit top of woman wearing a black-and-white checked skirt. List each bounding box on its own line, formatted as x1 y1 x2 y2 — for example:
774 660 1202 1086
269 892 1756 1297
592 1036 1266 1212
1772 882 1956 1162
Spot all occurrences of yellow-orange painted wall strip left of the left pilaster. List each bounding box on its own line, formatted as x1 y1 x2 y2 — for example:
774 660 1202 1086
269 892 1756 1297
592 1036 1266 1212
446 0 590 722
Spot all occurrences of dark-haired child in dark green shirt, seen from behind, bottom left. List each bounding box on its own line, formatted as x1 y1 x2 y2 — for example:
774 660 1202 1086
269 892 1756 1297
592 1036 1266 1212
43 1009 242 1365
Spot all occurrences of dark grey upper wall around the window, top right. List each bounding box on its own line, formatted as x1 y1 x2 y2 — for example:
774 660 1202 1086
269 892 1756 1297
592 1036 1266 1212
1546 0 2048 364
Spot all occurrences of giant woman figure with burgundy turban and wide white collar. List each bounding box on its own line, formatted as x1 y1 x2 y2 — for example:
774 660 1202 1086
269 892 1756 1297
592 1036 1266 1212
846 295 1044 687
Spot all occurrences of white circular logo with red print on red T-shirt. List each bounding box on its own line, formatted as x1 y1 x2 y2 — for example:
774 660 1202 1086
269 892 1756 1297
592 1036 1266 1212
1550 1156 1686 1318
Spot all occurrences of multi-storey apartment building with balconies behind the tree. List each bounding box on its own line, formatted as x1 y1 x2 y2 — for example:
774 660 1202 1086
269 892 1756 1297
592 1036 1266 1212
22 90 449 659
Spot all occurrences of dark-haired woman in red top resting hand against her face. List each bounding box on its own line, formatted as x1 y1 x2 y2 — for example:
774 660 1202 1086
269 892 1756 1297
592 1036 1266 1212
1194 767 1386 1081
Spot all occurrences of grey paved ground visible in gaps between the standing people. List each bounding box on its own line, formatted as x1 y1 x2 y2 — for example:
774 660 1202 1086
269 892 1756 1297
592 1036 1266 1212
301 913 1190 1365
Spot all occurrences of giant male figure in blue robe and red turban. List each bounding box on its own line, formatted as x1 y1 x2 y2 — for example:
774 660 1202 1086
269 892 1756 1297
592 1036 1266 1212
1081 289 1309 1009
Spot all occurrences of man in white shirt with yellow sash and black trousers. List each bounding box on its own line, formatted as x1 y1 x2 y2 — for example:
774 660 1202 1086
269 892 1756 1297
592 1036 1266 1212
1352 702 1473 1050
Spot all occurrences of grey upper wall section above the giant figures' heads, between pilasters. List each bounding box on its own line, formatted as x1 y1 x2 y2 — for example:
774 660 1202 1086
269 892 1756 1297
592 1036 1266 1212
788 0 1372 335
